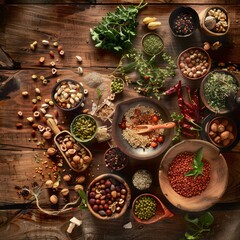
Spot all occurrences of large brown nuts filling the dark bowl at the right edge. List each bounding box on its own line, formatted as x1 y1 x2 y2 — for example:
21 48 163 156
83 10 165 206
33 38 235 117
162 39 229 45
208 118 235 147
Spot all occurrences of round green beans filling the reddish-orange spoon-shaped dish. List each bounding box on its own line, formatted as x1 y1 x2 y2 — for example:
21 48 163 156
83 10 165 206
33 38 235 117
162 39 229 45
133 196 157 220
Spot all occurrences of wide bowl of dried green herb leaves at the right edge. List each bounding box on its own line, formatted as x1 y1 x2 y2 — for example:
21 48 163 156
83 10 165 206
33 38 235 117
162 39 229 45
200 70 239 114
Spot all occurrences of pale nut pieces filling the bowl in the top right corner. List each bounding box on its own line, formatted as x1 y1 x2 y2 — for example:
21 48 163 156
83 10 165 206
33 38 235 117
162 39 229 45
204 8 228 33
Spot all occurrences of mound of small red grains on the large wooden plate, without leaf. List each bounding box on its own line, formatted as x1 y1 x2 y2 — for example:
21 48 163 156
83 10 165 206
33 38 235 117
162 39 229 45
168 151 210 198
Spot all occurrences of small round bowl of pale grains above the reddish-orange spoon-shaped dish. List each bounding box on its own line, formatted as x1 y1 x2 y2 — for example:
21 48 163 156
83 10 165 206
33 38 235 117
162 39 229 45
132 169 152 190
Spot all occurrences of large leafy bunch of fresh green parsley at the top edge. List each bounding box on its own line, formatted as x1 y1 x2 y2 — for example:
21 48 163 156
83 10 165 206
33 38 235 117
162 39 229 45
90 0 147 52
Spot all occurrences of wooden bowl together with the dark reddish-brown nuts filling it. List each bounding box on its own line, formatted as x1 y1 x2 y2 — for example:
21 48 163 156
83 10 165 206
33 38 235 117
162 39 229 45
87 173 131 220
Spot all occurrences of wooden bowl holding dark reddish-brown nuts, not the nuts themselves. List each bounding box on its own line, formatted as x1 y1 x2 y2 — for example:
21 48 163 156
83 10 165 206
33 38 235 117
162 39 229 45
87 173 131 220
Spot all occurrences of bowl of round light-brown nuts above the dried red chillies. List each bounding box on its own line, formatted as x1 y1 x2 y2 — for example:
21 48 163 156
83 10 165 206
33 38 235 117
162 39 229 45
177 47 212 80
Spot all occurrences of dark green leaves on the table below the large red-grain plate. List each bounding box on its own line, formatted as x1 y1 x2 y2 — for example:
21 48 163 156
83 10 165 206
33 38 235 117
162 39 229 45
180 212 214 240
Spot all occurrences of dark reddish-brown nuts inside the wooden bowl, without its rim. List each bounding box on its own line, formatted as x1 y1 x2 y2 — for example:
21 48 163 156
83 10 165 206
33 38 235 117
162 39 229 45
88 177 128 217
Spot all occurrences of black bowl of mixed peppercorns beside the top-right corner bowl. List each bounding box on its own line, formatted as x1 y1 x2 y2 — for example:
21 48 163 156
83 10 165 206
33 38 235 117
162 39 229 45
169 7 199 37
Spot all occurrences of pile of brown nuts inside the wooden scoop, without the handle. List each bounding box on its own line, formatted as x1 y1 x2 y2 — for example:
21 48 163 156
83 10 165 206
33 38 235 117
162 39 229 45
56 131 92 172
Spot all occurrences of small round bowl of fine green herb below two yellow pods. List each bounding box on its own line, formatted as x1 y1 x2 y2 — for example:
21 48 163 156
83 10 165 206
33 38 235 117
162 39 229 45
142 33 164 56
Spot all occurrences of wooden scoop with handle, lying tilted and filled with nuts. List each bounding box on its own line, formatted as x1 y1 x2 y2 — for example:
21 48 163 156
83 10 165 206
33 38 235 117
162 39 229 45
47 118 92 172
